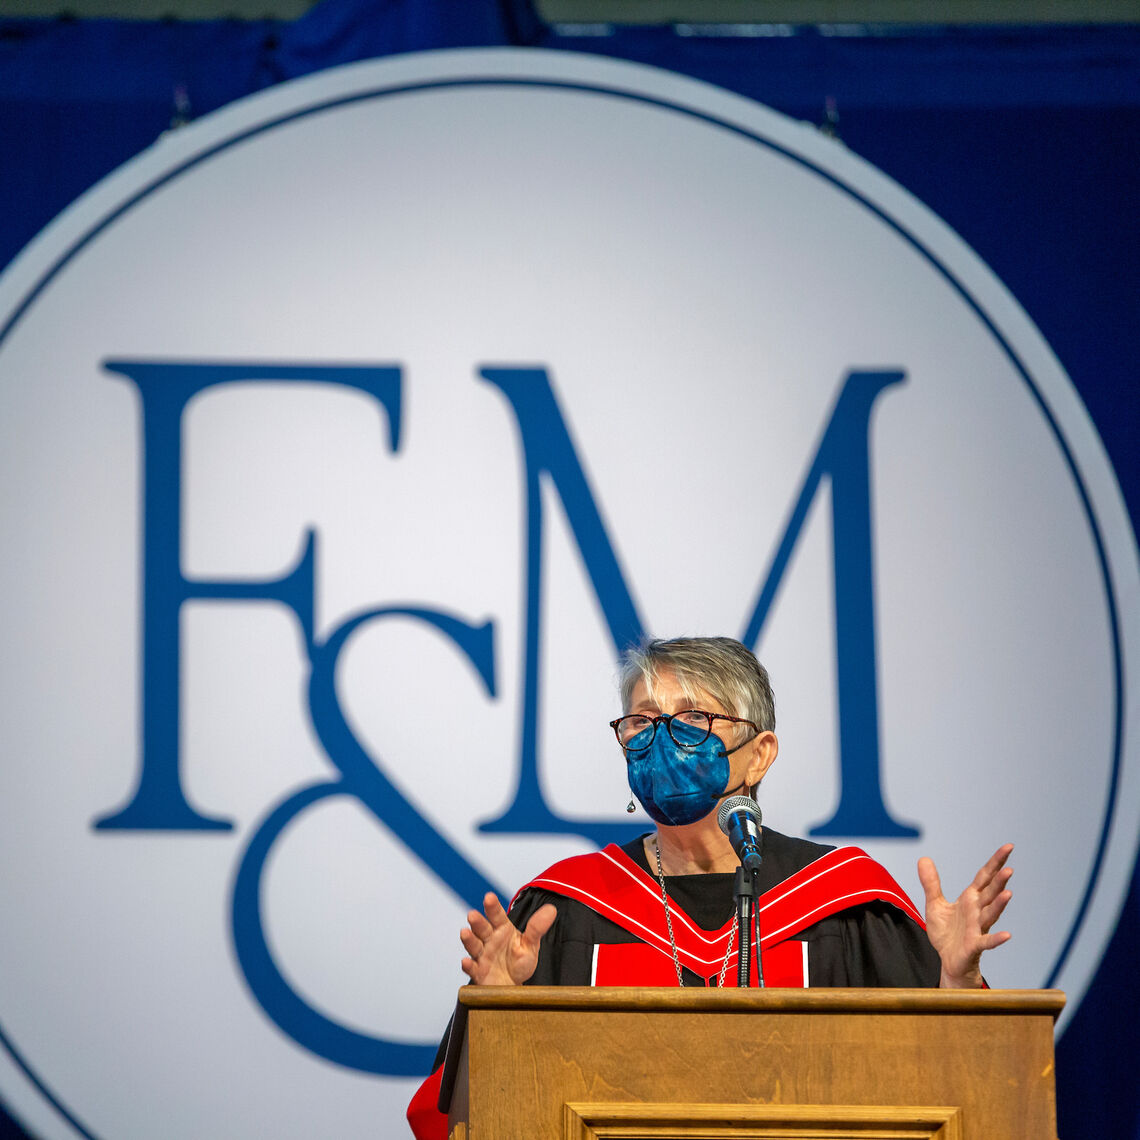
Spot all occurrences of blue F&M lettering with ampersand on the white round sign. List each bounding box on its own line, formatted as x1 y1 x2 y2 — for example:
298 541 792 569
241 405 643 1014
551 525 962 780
96 361 919 1075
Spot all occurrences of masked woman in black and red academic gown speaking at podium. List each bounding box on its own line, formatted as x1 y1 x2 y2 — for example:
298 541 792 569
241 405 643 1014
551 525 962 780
408 637 1012 1140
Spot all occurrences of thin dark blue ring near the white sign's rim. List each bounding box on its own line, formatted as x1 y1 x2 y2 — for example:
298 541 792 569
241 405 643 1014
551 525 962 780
0 68 1124 1140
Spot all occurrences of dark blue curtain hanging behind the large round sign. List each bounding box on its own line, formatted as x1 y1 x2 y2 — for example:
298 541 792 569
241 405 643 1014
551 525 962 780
0 0 1140 1140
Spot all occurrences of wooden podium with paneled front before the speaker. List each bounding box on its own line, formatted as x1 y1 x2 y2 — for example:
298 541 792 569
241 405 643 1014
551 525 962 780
440 986 1065 1140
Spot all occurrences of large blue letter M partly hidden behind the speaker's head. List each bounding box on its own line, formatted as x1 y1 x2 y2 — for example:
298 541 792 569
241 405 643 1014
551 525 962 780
480 367 919 842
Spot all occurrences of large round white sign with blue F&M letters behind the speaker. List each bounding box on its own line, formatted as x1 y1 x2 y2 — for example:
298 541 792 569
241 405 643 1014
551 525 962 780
0 50 1140 1140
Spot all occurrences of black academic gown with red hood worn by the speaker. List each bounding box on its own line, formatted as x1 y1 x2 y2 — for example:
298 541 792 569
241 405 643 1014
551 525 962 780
408 828 942 1140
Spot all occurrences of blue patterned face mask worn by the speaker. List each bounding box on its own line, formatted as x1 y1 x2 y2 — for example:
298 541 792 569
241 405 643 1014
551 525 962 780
626 720 735 828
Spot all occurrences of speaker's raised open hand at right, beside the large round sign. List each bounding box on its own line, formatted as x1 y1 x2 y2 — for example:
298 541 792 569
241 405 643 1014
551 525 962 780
919 844 1013 990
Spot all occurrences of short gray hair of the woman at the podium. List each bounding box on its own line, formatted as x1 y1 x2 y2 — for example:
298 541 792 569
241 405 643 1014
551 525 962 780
619 637 776 732
